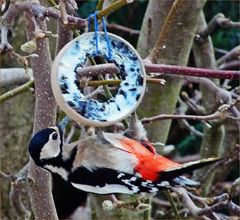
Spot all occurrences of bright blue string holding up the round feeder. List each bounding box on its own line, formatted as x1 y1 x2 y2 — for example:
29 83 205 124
88 12 112 60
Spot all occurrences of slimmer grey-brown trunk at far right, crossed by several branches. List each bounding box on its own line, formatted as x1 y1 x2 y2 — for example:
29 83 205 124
193 12 225 194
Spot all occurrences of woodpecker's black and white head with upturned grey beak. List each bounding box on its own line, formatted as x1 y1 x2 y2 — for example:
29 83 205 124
29 117 69 166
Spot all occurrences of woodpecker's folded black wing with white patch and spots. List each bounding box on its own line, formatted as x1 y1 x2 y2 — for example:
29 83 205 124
69 166 167 194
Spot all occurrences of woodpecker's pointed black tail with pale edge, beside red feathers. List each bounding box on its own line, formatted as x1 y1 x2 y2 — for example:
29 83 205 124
159 158 222 185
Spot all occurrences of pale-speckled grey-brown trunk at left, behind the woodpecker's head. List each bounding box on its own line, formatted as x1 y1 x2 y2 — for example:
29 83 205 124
26 13 58 219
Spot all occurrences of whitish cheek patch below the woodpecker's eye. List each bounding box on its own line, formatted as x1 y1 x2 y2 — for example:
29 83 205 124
40 140 61 159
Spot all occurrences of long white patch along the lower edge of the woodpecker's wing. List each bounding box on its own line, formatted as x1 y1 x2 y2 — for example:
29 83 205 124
72 183 134 194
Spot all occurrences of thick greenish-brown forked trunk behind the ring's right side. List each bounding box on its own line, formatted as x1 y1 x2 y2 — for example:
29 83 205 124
138 0 206 142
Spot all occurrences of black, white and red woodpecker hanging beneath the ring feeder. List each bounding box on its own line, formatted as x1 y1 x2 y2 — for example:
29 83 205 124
29 115 218 194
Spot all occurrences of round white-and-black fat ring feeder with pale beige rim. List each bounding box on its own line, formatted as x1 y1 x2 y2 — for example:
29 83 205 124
51 32 146 127
